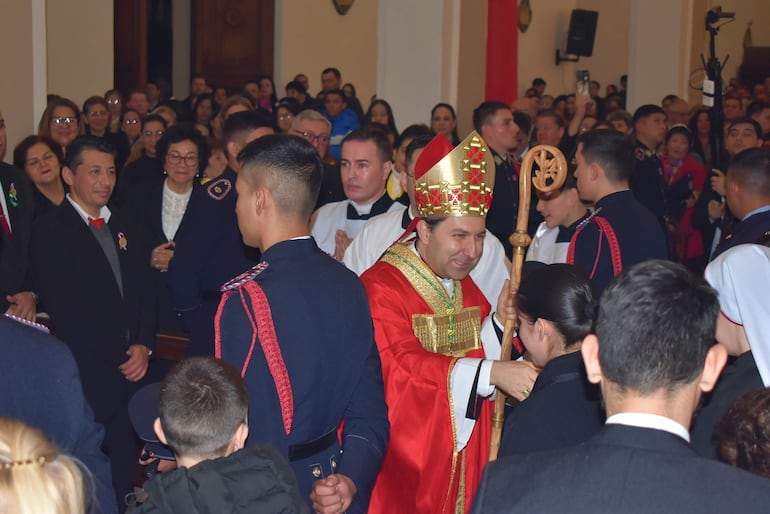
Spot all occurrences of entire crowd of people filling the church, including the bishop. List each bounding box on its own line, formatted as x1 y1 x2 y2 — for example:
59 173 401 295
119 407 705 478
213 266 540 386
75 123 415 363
0 68 770 514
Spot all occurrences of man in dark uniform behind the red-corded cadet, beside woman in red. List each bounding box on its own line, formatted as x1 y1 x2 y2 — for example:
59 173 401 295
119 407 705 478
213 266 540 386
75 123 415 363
631 104 668 228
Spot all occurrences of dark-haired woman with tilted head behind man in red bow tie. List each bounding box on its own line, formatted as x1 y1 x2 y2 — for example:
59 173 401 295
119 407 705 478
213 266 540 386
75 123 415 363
13 136 66 218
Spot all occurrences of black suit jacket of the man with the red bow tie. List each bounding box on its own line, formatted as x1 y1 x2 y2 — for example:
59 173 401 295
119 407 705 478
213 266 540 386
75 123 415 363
30 199 155 422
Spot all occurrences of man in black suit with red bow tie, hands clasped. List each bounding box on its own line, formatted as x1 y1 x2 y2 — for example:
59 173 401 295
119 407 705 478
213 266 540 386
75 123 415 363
30 136 155 504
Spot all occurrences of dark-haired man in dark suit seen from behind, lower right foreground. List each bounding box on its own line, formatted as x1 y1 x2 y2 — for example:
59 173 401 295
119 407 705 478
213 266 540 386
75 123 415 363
473 260 770 513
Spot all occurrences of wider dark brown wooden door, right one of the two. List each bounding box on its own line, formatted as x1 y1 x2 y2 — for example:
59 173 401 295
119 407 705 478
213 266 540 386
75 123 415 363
191 0 275 91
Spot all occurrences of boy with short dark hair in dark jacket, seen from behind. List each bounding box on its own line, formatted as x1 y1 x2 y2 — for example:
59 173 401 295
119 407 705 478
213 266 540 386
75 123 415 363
136 357 307 513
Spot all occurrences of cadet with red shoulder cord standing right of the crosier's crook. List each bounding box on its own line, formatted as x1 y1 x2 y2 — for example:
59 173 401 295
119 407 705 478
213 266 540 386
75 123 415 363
567 129 668 293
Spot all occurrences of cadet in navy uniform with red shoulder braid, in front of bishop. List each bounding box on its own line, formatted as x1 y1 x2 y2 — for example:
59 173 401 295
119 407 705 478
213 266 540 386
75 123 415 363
216 135 389 513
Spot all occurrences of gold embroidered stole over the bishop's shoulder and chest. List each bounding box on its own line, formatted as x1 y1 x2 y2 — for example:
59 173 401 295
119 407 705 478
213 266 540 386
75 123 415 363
382 243 481 357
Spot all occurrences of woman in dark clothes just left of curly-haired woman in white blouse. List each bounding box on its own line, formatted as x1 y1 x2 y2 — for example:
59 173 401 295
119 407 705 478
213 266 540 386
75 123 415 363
112 114 167 206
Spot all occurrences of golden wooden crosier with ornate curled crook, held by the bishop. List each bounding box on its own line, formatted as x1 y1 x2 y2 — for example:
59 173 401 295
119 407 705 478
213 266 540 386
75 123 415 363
489 145 567 461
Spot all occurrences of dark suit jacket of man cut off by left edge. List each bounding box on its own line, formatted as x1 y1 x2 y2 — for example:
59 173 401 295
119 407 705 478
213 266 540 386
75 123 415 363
0 162 35 312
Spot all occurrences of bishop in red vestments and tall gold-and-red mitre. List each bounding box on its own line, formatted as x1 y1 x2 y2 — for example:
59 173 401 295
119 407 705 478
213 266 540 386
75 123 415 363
361 132 536 513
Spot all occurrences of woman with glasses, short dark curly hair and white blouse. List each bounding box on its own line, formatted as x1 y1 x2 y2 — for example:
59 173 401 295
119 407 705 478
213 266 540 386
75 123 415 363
125 123 209 332
